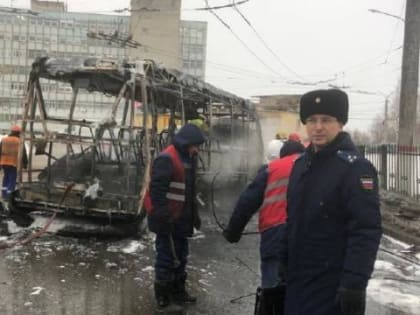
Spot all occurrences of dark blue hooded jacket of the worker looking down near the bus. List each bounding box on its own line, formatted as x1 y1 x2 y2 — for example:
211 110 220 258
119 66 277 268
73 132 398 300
148 124 205 237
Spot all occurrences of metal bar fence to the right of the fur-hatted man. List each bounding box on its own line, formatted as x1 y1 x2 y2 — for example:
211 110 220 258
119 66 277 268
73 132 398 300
359 144 420 202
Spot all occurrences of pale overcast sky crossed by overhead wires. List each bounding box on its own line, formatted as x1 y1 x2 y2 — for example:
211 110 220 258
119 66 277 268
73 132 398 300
0 0 405 130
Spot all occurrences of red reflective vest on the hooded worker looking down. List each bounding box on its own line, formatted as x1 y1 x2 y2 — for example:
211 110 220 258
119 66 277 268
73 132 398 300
144 144 185 218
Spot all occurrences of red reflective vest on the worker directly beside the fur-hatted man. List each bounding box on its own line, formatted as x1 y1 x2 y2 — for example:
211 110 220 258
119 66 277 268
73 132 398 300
258 153 299 233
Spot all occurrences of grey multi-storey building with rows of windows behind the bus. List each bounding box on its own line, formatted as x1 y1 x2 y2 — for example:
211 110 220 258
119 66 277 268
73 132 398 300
0 0 206 128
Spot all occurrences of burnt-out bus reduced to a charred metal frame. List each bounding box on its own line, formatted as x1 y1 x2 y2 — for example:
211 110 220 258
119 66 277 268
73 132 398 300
9 57 263 236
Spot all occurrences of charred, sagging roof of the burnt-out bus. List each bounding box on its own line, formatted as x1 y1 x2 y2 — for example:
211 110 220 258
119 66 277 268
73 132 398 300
31 57 252 110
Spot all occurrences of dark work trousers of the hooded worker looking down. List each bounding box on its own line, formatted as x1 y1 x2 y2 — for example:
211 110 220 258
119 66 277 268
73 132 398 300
155 233 188 281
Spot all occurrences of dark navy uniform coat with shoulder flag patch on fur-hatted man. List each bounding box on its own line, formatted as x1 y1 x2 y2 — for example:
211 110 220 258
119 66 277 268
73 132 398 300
282 132 382 315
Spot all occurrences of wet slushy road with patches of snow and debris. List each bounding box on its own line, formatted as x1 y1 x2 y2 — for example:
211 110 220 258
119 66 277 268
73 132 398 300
0 217 420 315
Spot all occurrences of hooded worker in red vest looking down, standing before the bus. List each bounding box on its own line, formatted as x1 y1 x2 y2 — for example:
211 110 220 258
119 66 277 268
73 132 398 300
144 123 206 312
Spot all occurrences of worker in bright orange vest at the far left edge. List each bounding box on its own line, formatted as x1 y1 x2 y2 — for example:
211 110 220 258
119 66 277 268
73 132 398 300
0 125 28 199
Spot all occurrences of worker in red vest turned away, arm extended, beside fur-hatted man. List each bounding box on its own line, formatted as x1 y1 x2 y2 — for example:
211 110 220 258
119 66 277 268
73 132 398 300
223 135 304 315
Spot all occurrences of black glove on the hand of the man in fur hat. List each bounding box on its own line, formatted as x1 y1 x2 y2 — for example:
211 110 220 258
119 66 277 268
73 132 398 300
336 287 366 315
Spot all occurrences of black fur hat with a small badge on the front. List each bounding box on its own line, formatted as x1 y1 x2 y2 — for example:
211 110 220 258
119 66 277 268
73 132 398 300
300 89 349 124
